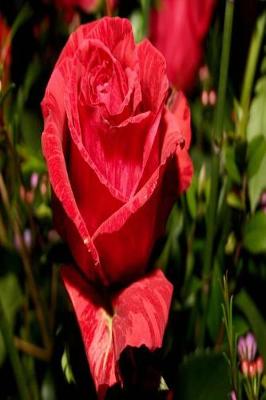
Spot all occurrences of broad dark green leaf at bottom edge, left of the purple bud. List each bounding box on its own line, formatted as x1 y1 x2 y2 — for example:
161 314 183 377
175 352 230 400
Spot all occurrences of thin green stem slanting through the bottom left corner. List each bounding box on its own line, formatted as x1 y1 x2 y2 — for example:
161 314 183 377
0 301 30 400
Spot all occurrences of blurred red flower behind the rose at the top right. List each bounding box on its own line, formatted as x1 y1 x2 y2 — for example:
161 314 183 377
150 0 216 92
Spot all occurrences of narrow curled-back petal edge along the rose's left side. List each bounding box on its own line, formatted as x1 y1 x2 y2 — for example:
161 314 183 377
42 63 106 282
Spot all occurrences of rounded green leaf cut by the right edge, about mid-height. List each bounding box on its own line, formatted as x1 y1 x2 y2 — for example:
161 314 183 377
243 211 266 254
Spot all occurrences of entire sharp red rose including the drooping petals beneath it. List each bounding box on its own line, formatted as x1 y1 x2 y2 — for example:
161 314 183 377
42 18 192 392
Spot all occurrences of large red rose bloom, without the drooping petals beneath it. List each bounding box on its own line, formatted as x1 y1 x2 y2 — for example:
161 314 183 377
42 18 192 284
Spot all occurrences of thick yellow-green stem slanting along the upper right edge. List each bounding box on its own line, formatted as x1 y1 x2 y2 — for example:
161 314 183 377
237 12 266 138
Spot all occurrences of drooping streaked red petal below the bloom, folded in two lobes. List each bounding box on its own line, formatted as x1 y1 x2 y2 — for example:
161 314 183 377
62 266 173 398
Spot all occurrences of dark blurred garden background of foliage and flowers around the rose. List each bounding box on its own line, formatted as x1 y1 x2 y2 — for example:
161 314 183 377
0 0 266 400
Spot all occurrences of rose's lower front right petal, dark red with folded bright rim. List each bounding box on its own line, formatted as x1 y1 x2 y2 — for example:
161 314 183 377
92 108 182 282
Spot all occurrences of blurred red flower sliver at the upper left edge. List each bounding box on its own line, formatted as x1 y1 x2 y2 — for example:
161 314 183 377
0 14 11 89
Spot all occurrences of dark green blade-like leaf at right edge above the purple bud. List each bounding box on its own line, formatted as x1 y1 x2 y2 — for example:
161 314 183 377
234 290 266 360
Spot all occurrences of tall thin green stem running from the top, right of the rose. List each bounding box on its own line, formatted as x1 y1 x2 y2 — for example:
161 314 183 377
200 0 234 346
